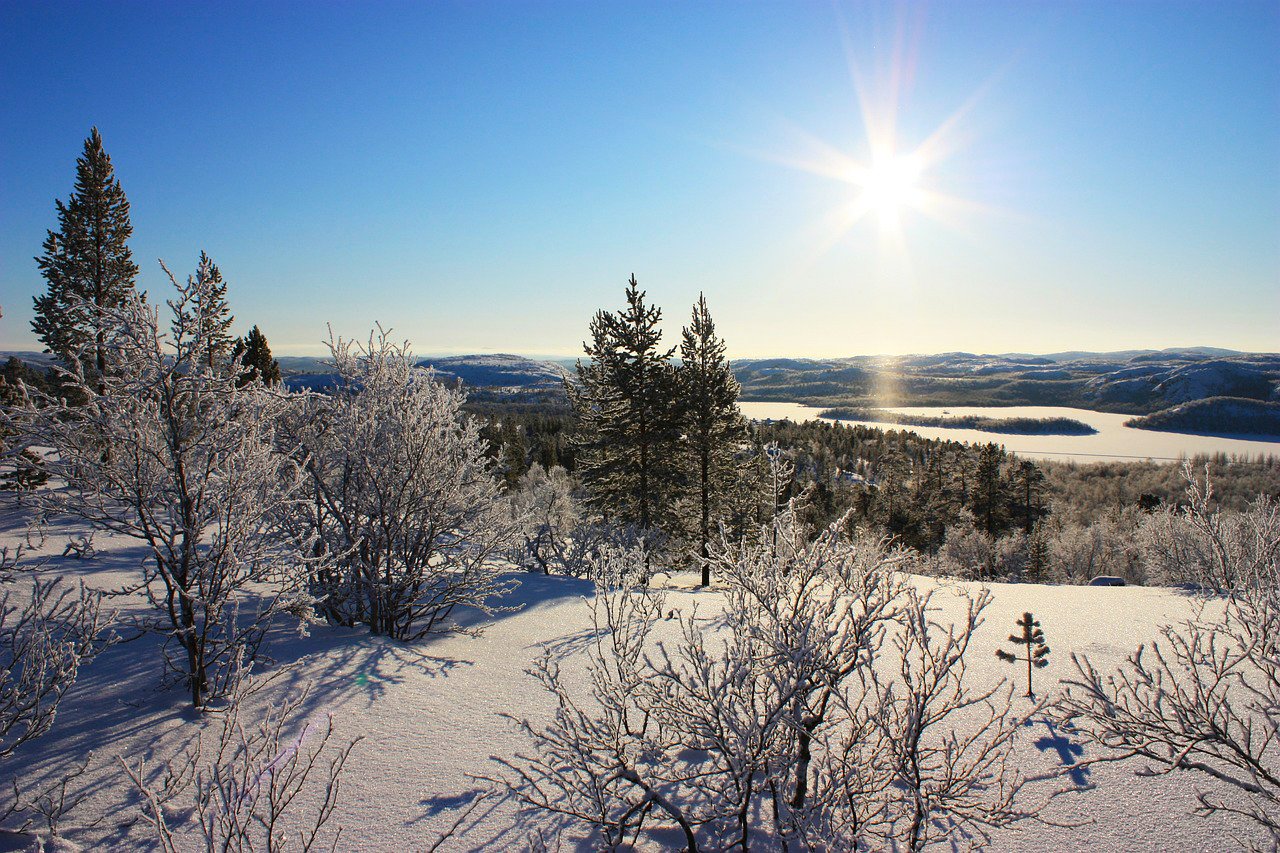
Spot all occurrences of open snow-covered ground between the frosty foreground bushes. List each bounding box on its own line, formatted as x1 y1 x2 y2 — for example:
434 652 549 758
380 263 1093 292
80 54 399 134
0 494 1261 852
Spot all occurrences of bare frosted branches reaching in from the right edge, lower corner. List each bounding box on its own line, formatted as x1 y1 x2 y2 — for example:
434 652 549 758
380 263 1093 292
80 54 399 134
1061 466 1280 845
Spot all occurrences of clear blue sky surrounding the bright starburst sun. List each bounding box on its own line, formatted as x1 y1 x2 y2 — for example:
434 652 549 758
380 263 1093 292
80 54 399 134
0 0 1280 356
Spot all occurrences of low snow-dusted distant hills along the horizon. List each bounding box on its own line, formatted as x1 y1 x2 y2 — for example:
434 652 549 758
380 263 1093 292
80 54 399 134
0 347 1280 415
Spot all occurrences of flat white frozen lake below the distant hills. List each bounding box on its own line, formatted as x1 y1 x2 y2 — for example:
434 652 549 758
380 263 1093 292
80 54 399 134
739 402 1280 462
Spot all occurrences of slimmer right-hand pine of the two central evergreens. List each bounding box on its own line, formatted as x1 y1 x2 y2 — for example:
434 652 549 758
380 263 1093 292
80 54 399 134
677 293 746 587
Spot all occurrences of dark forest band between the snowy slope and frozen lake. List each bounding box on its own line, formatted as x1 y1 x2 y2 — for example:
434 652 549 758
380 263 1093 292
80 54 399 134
485 394 1280 583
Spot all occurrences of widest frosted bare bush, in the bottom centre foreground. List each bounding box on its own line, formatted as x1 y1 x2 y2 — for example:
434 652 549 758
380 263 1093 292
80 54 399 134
494 512 1039 850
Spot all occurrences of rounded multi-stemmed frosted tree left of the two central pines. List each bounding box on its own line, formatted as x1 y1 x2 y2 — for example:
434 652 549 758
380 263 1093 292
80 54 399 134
285 329 521 640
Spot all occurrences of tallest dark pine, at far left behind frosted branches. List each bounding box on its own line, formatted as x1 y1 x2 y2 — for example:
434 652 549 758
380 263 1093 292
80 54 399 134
31 127 138 386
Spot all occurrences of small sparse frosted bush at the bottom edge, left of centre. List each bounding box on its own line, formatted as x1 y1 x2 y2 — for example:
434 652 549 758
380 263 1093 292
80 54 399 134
122 693 361 853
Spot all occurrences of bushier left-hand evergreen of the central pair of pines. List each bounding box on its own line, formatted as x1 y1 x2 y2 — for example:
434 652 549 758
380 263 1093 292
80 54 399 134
567 275 680 548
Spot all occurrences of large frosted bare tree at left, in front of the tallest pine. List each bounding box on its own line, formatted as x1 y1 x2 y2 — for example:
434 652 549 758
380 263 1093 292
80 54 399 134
6 257 316 707
